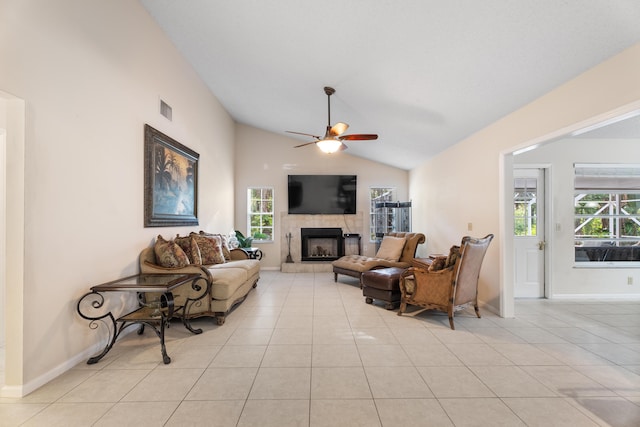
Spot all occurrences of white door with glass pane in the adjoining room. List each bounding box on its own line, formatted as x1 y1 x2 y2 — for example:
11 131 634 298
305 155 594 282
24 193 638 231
513 169 546 298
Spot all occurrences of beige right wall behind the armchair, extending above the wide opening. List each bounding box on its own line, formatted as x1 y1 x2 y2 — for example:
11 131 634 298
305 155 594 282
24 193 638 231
409 44 640 315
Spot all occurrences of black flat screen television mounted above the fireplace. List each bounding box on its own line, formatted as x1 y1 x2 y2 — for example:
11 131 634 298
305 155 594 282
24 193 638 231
288 175 357 215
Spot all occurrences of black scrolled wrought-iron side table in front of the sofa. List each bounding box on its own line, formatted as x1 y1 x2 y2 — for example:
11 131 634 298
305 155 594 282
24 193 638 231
77 274 210 365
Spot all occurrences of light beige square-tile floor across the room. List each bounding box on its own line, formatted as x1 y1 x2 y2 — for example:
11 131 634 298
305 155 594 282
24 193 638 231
0 271 640 427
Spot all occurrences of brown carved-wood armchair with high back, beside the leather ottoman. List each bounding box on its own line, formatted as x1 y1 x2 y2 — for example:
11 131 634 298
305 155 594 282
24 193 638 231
398 234 493 329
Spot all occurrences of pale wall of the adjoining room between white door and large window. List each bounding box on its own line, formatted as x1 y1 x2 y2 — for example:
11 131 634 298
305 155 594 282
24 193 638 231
514 138 640 297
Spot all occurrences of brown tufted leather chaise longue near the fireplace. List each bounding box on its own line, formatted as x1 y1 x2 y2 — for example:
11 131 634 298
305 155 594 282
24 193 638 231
332 233 426 282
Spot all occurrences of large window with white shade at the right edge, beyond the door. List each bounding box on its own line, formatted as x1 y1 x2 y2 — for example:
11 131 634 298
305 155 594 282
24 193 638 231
574 164 640 265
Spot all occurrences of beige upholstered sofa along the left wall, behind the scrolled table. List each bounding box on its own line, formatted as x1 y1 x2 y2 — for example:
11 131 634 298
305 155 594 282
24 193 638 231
140 247 260 325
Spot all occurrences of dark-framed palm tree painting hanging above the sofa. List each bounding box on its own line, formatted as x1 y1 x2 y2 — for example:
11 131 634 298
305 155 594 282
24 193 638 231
144 125 200 227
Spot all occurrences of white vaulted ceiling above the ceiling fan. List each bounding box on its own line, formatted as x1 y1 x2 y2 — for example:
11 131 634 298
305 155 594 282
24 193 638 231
141 0 640 169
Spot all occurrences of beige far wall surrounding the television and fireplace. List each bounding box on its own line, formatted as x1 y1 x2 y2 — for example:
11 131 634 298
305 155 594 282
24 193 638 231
235 125 409 268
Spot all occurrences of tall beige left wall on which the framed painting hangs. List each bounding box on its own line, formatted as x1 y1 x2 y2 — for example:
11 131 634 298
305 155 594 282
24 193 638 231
0 0 235 394
